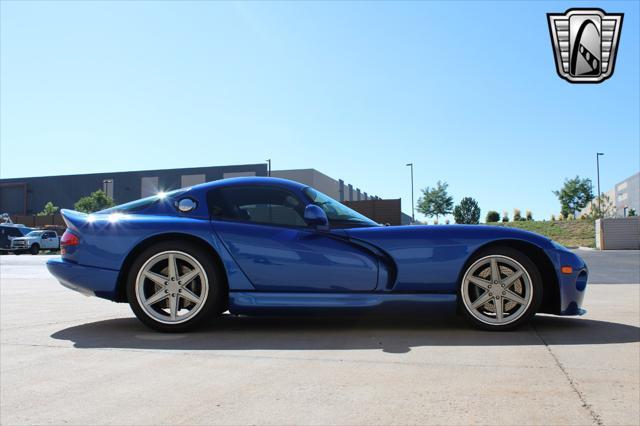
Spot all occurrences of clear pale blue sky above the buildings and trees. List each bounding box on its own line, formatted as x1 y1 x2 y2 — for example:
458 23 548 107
0 1 640 218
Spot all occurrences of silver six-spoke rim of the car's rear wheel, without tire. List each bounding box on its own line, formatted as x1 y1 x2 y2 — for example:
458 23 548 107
135 251 209 324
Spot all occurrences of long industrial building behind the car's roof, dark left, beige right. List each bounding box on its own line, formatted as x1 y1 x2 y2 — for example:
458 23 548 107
0 163 408 225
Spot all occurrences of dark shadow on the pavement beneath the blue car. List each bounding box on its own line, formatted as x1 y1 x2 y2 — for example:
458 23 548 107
51 315 640 353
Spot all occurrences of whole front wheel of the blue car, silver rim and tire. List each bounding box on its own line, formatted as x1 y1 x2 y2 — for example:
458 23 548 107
459 247 543 330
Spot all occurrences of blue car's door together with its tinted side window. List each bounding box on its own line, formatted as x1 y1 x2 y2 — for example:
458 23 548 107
208 186 378 292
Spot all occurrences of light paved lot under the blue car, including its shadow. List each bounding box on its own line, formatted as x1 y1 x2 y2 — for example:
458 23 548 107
0 252 640 425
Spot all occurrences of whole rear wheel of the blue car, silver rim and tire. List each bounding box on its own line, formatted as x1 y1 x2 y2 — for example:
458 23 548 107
127 241 224 332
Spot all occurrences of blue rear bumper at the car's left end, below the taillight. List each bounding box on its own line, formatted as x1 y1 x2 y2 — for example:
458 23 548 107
47 258 119 300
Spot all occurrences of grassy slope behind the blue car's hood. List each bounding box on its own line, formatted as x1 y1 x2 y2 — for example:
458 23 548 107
487 220 596 247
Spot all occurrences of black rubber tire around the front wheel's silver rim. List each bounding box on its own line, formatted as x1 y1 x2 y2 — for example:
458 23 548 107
458 246 543 331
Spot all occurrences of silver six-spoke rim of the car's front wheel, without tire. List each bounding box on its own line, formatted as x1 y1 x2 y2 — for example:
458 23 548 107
461 255 533 325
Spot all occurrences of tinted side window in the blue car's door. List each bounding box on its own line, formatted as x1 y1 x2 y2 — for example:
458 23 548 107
207 186 306 227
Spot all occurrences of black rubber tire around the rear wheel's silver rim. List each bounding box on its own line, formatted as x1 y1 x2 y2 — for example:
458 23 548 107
127 240 227 333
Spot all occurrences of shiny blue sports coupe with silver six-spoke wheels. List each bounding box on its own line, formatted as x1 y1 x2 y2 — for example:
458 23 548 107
47 177 587 332
